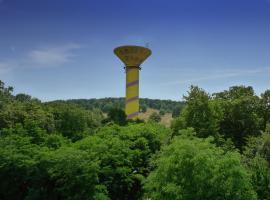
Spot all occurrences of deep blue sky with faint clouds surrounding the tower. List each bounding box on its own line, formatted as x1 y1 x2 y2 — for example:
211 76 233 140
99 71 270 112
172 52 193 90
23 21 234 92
0 0 270 101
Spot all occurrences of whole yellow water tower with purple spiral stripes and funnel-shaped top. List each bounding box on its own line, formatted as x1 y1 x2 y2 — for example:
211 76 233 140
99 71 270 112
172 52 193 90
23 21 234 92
114 46 151 119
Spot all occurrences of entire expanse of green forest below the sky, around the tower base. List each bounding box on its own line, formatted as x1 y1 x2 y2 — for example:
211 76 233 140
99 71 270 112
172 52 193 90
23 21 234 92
0 81 270 200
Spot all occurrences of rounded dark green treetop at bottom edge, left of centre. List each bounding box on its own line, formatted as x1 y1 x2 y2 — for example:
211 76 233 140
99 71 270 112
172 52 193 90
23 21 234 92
38 147 109 200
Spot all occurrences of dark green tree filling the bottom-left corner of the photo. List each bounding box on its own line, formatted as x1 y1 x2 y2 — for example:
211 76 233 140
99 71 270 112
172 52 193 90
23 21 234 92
0 135 39 200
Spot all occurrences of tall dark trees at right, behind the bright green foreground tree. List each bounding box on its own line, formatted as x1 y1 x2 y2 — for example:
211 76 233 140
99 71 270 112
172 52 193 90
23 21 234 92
172 86 270 151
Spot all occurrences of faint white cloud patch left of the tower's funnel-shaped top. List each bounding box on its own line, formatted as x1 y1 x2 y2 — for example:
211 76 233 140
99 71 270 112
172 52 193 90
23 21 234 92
26 44 81 67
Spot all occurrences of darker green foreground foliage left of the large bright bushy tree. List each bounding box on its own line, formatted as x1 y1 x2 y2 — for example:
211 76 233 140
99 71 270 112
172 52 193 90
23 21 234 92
0 121 169 199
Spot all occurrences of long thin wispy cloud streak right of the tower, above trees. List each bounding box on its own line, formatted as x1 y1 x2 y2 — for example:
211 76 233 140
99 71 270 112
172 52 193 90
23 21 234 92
162 67 270 85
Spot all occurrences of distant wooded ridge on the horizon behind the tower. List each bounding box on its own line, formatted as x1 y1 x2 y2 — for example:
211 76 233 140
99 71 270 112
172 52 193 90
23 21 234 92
49 98 185 116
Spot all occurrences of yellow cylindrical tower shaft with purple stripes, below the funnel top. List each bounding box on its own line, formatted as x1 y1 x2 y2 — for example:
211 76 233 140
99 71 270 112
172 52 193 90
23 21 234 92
125 66 139 119
